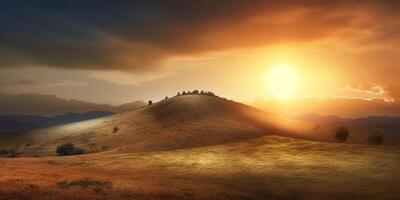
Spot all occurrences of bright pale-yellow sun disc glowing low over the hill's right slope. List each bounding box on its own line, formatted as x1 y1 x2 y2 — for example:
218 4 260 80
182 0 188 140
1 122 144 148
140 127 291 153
267 66 299 101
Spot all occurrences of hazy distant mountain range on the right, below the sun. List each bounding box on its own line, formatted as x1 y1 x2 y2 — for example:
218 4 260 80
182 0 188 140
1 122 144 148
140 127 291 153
297 113 400 134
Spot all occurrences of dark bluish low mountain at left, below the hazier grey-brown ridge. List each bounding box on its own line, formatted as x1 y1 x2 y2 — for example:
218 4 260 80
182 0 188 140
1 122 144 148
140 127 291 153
0 111 114 133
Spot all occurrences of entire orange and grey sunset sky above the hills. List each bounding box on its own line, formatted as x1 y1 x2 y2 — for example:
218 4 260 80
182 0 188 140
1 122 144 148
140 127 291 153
0 0 400 115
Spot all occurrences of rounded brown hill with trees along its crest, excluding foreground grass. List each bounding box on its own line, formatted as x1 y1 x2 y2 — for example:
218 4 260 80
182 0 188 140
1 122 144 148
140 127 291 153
0 95 332 156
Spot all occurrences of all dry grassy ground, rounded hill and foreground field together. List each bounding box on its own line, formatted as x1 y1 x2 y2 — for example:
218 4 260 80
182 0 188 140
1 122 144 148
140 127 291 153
0 96 400 200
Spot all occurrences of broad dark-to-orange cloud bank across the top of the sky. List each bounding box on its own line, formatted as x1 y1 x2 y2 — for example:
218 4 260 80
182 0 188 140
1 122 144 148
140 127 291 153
0 0 399 71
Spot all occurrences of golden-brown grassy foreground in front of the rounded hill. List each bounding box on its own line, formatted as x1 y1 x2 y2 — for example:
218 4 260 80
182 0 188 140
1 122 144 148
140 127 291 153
0 136 400 200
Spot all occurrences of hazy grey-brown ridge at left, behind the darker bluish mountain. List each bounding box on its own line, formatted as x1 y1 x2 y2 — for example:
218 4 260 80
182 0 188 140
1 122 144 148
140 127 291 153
0 94 146 116
